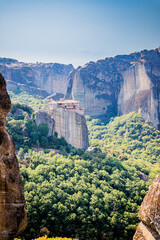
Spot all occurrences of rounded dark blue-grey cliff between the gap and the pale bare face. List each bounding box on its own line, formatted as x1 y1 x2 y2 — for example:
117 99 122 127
66 60 122 116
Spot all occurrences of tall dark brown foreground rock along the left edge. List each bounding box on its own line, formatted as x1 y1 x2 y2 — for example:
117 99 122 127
0 74 27 240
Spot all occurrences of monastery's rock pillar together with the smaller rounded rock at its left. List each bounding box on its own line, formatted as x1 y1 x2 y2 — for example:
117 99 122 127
36 108 89 149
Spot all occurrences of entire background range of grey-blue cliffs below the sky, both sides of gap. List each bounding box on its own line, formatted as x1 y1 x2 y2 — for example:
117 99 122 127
0 47 160 129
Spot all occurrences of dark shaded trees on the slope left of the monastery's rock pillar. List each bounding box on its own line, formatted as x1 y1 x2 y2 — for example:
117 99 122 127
6 102 74 154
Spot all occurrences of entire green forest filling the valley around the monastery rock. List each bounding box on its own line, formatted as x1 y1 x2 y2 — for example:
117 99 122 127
7 92 160 240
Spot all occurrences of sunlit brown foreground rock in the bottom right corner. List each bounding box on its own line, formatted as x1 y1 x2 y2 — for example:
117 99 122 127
133 174 160 240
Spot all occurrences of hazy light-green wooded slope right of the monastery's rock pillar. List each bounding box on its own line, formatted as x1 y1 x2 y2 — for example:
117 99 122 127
87 112 160 182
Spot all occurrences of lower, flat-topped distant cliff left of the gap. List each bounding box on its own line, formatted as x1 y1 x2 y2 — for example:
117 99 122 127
0 58 73 95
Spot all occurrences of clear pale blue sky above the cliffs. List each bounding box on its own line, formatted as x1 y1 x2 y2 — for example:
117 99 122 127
0 0 160 67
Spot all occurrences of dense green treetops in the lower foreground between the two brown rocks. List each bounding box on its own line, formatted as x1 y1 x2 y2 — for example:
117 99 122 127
21 151 147 240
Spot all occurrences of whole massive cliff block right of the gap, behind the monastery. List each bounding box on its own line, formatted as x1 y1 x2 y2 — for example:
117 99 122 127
66 48 160 128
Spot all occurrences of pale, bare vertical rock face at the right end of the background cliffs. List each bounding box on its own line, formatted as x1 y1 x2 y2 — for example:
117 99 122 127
118 62 160 127
